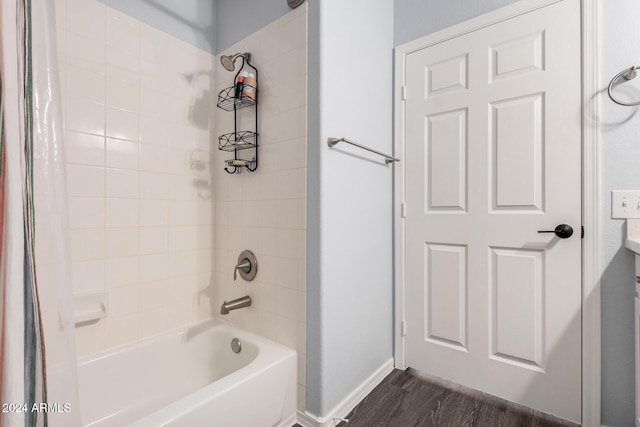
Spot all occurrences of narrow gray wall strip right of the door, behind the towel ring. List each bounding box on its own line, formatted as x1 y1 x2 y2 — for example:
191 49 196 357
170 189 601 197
599 0 640 426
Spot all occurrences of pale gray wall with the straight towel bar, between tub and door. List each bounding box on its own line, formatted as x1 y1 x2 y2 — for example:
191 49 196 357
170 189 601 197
307 0 393 417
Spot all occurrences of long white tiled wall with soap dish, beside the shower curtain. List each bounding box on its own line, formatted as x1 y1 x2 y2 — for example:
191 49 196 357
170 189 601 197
55 0 215 357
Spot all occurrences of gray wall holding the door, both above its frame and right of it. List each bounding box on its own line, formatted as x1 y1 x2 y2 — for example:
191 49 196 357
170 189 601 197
394 0 640 427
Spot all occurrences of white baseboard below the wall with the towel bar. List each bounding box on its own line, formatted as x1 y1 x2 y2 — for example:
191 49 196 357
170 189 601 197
298 359 393 427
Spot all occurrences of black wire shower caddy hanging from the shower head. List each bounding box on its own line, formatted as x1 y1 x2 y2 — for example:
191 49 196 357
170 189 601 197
217 53 258 174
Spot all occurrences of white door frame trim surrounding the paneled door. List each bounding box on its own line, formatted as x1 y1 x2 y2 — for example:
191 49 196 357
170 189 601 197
393 0 601 427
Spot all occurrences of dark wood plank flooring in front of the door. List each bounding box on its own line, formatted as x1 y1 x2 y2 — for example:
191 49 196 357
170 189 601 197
339 369 577 427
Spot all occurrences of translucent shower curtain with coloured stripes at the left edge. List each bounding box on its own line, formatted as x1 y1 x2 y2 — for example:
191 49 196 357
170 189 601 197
0 0 81 427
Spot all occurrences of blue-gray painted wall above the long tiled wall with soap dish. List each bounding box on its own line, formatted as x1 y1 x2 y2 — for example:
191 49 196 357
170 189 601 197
98 0 216 54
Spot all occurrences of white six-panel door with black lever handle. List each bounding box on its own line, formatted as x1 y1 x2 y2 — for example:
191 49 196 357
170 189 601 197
404 0 581 422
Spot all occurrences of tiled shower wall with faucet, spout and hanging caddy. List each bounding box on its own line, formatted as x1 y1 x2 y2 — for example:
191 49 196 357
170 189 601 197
212 4 307 409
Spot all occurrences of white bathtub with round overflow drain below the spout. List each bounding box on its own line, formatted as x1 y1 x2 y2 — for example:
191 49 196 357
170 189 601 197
78 320 297 427
